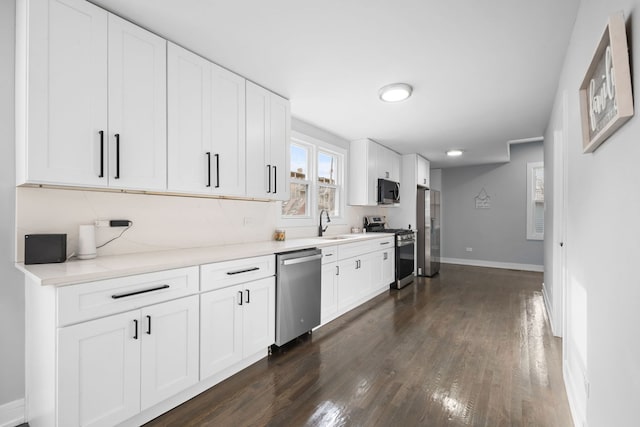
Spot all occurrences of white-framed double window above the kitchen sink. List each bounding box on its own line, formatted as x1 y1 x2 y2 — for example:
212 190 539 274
281 132 346 226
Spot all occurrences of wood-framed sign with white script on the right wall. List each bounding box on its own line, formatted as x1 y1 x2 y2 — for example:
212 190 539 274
580 12 633 153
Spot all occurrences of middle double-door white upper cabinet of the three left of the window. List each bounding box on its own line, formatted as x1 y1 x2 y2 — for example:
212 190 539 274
167 43 246 196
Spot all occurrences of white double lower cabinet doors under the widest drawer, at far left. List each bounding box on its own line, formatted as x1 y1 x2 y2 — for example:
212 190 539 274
57 295 198 426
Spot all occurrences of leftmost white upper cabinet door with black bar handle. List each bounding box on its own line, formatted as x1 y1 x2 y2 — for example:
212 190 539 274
24 0 108 187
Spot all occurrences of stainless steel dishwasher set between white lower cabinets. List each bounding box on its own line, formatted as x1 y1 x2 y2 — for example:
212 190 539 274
276 248 322 346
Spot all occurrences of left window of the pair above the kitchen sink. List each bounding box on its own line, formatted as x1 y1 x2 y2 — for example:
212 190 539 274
282 143 312 218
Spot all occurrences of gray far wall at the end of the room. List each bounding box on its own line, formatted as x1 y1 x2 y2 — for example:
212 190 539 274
442 142 543 266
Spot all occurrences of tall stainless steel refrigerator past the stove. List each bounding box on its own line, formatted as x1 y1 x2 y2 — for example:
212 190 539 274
416 187 440 277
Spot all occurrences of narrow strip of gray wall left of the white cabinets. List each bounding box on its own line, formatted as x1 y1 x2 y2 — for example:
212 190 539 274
0 0 24 406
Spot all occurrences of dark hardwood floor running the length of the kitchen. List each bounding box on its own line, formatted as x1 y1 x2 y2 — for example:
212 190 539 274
148 264 573 427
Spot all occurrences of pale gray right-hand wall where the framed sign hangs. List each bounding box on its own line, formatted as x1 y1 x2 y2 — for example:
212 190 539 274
545 0 640 426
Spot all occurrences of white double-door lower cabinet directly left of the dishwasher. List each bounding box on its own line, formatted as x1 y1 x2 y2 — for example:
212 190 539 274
200 276 276 379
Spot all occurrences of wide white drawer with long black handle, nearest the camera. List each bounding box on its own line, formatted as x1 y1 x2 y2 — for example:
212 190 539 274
57 266 198 326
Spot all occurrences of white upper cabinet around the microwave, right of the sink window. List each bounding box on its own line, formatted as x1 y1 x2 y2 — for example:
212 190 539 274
349 139 402 206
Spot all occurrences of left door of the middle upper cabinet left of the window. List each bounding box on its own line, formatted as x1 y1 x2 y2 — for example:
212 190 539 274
167 43 215 193
